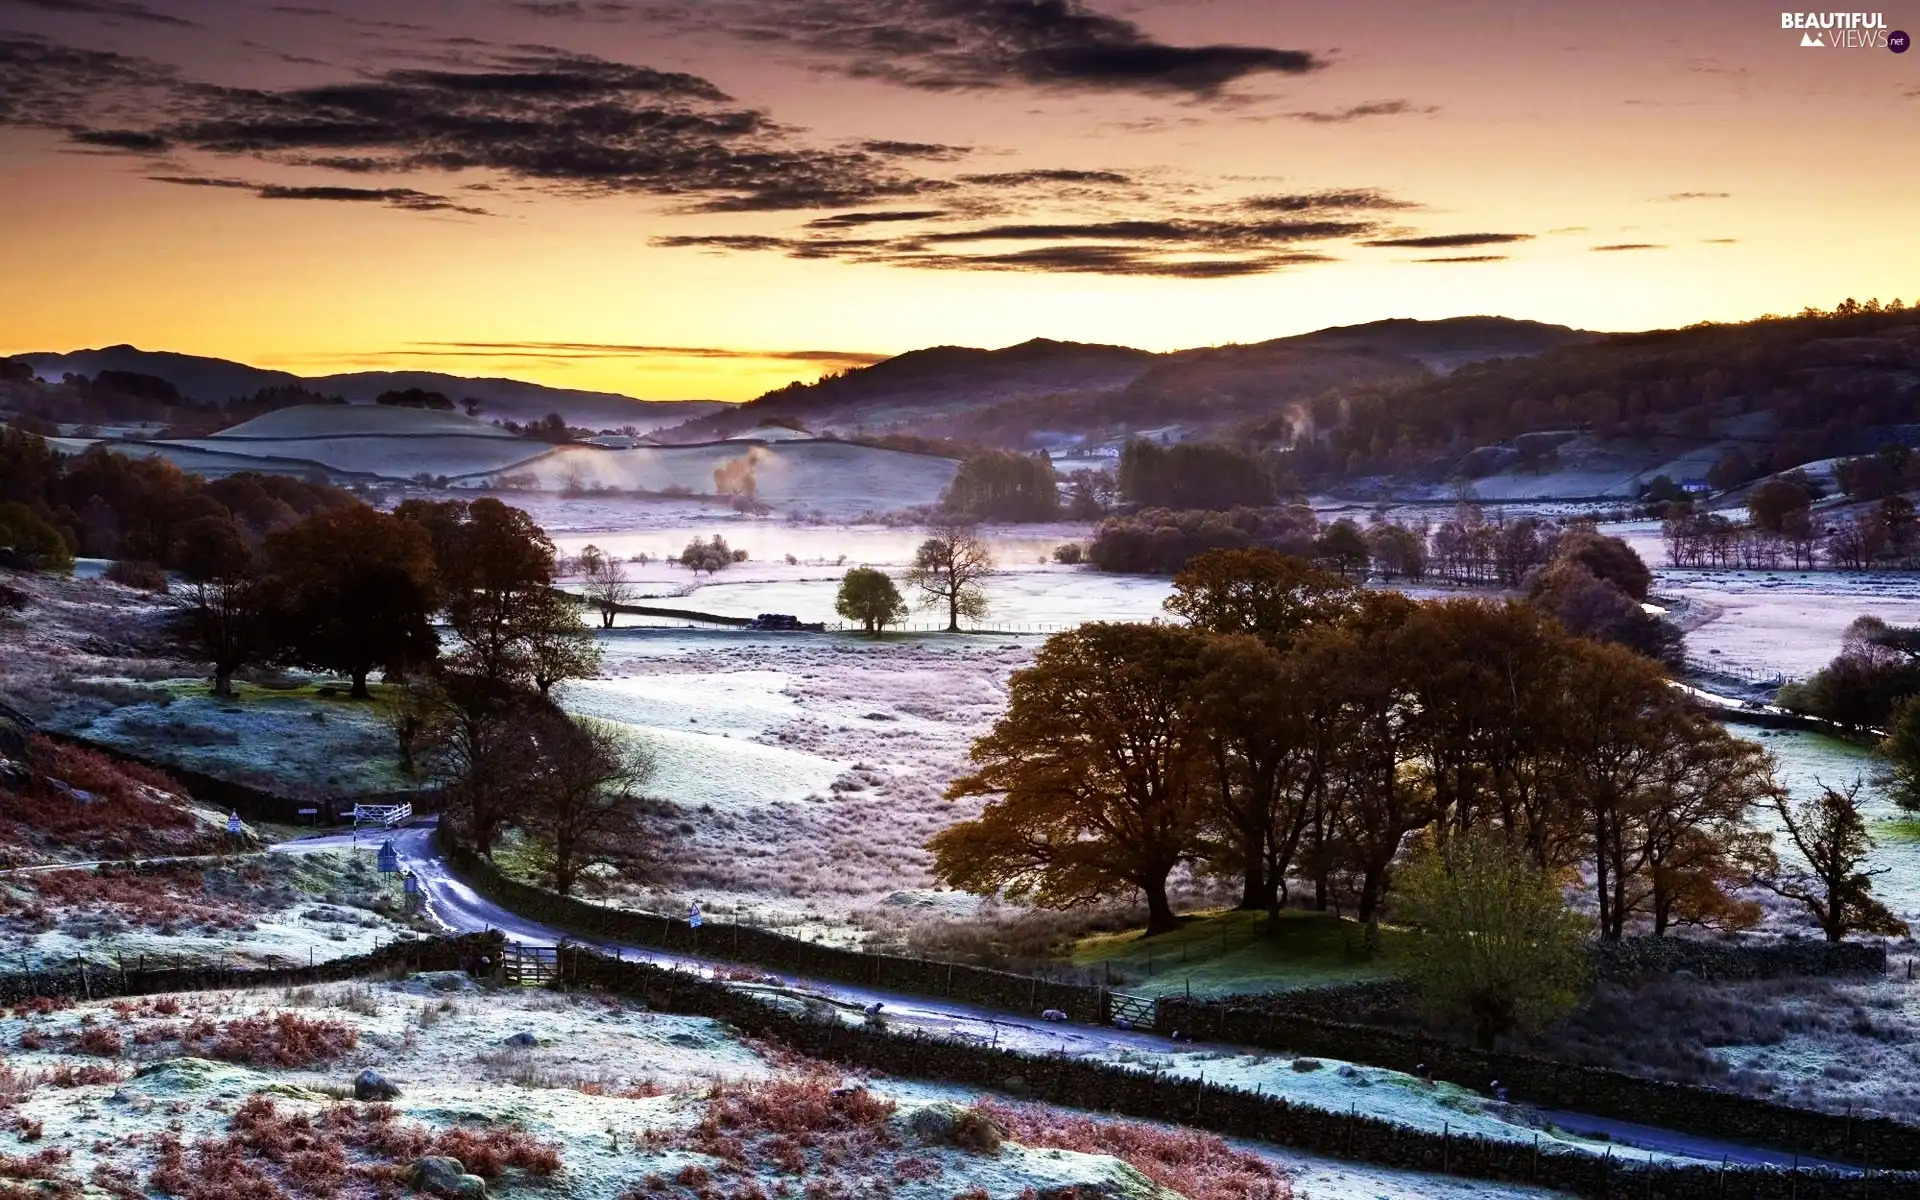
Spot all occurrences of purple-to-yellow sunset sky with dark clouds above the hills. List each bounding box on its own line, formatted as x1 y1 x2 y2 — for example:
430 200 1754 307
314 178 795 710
0 0 1920 399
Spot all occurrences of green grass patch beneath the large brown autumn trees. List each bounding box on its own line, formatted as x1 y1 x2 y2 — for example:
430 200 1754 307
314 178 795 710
1068 908 1404 996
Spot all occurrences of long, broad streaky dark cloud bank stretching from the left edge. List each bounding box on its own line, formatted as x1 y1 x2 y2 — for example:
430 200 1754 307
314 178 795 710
0 40 954 211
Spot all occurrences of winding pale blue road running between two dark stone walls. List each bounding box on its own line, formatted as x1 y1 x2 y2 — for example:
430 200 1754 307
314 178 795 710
269 818 1851 1171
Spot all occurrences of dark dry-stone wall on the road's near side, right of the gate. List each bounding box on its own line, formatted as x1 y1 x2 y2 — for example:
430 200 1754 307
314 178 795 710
559 947 1920 1200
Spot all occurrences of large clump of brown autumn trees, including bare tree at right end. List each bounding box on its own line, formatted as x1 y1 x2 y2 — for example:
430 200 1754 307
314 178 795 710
929 549 1897 956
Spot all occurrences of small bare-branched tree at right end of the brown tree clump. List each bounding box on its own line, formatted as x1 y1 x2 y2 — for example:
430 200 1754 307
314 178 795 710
1759 780 1907 941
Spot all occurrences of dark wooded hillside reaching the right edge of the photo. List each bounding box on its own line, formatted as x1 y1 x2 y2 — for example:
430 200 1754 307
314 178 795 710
1267 305 1920 495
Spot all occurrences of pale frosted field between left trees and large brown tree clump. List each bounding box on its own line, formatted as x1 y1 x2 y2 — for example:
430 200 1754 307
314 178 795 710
563 630 1039 922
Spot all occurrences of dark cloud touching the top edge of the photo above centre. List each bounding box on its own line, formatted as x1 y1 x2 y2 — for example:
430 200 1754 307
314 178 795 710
647 0 1323 98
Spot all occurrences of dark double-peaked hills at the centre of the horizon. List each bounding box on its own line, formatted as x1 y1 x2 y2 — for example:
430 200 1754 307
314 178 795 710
662 317 1596 449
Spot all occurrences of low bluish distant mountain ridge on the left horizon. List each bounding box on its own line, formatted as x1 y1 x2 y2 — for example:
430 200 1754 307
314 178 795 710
10 346 720 428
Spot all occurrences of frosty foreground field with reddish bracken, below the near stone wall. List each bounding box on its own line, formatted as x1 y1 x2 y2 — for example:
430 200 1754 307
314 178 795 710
0 973 1582 1200
